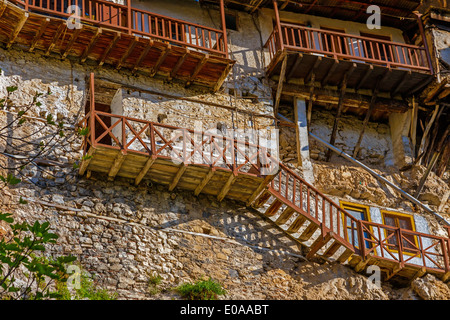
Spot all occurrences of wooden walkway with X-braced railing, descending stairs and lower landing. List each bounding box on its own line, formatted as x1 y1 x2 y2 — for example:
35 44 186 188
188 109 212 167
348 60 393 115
79 74 450 283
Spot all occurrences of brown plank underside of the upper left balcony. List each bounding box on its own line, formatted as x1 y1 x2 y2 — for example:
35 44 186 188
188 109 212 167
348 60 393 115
0 1 234 91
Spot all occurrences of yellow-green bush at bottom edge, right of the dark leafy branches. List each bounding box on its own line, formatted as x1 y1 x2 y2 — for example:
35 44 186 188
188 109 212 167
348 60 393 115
56 268 117 300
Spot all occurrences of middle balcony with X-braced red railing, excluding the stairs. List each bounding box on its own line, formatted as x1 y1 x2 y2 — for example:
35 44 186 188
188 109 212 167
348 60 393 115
79 74 278 202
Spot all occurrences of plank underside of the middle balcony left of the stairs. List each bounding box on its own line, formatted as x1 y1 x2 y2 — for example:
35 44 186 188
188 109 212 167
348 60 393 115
85 145 264 202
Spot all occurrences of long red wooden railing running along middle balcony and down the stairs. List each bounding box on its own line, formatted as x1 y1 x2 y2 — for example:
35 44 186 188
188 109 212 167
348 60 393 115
79 74 450 274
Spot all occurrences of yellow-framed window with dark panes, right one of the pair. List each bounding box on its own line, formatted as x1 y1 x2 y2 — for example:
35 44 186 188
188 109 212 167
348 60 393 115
381 211 418 253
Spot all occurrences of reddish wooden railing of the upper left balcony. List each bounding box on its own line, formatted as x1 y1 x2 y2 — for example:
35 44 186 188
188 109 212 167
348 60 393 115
12 0 227 57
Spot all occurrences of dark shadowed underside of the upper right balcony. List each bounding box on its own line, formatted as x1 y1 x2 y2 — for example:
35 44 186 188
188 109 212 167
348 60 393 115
267 50 433 96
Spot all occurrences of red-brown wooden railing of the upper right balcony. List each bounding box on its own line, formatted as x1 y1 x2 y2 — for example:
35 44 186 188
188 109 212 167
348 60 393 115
265 23 431 72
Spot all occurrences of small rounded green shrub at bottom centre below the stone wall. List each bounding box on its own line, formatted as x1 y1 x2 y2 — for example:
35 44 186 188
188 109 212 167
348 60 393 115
175 278 227 300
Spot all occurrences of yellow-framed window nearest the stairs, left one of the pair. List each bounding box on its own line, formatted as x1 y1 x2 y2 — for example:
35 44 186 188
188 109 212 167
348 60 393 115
340 201 372 249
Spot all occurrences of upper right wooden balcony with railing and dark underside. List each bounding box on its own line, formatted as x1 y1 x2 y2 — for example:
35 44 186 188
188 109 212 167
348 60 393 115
265 22 432 97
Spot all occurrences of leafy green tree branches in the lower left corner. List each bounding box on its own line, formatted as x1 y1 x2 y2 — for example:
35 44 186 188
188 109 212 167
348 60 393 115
0 213 75 300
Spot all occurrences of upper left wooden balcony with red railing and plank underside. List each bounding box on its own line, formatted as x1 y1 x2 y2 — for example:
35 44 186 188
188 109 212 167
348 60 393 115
0 0 234 90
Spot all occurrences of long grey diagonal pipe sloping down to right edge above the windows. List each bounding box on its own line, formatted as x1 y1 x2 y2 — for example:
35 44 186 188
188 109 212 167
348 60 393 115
309 132 450 226
